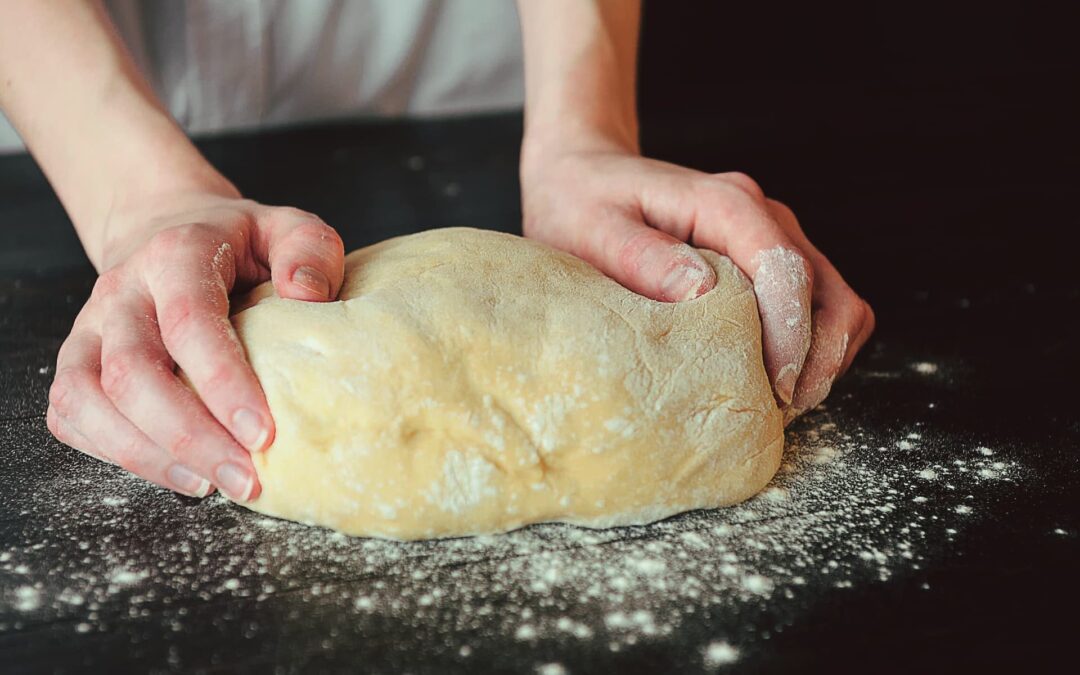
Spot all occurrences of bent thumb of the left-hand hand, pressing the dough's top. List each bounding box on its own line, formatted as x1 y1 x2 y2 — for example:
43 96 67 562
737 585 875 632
255 206 345 301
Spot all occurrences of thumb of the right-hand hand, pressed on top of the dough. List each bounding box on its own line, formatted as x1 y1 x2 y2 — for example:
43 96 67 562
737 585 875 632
552 218 716 302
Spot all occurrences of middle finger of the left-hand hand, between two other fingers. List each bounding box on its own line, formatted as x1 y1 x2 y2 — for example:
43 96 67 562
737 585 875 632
102 291 259 501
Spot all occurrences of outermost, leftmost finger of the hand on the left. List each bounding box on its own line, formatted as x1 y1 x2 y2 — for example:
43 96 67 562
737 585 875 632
45 332 212 497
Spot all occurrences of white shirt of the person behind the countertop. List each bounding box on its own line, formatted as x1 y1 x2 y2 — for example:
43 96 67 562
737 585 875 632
0 0 524 151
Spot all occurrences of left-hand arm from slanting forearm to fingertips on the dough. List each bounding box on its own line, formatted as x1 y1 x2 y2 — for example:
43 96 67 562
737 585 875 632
0 0 342 500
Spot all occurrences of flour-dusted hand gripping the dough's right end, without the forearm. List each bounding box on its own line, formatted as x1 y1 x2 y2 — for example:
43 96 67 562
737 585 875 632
522 138 874 423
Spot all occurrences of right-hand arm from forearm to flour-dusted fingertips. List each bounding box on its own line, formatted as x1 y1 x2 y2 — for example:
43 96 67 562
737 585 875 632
518 0 874 420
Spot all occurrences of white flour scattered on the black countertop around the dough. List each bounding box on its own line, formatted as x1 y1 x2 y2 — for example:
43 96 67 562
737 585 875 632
0 373 1028 672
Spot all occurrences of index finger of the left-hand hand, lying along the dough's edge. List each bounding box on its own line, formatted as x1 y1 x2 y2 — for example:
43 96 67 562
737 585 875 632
141 226 274 453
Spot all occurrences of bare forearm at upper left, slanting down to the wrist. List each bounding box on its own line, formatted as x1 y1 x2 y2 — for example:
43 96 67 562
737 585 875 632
0 0 235 268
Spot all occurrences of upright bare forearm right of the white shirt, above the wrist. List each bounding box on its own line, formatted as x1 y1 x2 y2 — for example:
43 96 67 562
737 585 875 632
518 0 640 152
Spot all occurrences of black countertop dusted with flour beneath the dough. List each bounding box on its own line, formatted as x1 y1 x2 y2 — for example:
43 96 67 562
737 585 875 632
0 81 1080 673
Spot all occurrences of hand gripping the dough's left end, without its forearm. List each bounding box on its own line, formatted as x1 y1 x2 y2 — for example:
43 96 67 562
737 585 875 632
46 192 343 501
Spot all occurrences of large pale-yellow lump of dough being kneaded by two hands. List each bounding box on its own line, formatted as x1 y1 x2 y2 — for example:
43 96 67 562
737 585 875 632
232 228 784 539
